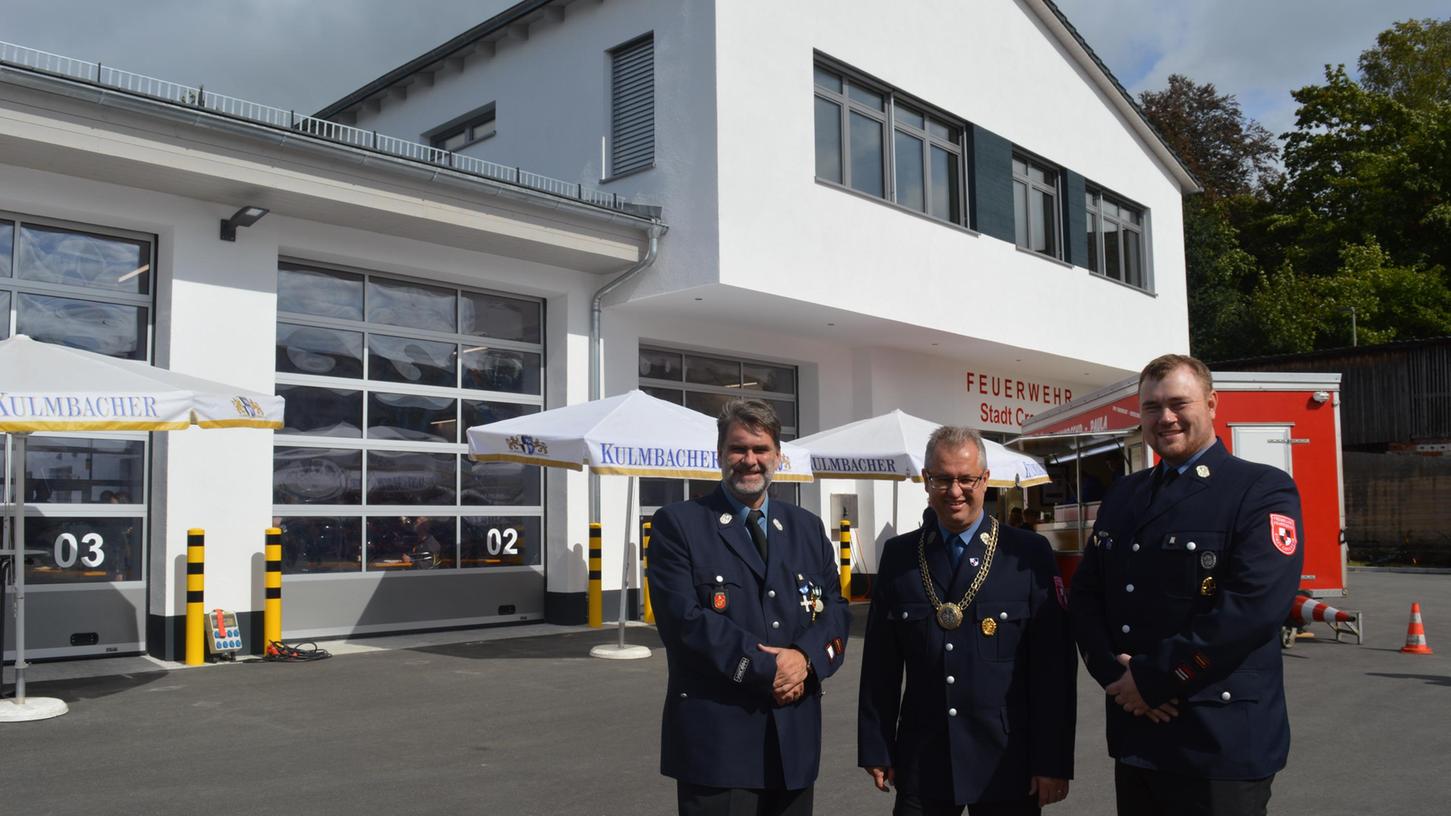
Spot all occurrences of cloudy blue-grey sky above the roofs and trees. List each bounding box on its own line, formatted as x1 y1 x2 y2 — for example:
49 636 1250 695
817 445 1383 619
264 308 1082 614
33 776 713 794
0 0 1451 134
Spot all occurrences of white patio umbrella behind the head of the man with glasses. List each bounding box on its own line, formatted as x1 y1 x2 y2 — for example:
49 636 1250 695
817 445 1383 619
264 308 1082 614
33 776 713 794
795 411 1049 529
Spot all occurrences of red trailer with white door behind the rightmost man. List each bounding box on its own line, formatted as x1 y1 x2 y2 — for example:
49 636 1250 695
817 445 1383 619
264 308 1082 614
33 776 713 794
1013 372 1345 597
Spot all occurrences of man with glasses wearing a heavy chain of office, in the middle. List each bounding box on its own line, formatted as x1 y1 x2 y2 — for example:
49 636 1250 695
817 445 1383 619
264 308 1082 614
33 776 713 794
856 427 1078 816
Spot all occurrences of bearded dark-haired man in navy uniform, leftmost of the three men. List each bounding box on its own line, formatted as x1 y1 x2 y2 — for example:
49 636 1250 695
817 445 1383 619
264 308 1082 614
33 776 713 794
650 399 850 816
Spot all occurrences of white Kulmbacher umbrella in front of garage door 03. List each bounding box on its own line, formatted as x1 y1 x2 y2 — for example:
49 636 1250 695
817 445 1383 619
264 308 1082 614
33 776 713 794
0 334 283 722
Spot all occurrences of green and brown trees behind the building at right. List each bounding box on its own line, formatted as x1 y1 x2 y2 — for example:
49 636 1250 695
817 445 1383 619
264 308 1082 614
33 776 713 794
1142 20 1451 360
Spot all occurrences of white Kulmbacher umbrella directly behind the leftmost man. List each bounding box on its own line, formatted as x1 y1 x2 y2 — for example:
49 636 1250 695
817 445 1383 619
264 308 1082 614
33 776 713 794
467 391 811 658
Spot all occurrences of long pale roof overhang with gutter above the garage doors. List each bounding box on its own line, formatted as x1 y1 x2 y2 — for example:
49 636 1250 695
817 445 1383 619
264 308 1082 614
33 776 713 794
0 70 651 273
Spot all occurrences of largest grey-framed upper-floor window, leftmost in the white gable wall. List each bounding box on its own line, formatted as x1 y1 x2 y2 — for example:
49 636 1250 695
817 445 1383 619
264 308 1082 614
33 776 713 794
815 65 965 224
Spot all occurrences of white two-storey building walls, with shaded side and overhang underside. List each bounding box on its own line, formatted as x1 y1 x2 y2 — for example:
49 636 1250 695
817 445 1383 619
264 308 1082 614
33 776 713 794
333 0 1188 575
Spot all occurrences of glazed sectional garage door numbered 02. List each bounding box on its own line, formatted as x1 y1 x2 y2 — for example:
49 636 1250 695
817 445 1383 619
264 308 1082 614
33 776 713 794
273 261 544 635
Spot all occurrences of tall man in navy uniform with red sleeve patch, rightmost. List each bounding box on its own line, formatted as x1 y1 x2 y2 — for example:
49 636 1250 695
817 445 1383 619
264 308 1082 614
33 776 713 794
1071 354 1304 816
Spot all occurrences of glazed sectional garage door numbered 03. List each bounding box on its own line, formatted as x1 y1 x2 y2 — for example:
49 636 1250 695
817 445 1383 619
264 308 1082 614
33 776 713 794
0 213 155 659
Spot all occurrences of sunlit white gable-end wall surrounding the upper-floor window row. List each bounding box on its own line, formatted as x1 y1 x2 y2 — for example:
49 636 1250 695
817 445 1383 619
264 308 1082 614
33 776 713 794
717 0 1188 370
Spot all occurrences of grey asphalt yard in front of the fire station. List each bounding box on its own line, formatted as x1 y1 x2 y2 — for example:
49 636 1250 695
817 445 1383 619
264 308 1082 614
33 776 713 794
0 572 1451 816
